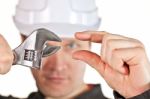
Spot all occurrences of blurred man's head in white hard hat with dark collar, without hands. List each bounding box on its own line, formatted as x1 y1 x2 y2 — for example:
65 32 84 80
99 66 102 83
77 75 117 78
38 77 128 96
2 0 106 99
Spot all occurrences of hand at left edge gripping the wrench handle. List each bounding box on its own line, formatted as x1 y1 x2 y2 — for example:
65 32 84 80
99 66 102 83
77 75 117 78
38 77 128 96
0 35 14 74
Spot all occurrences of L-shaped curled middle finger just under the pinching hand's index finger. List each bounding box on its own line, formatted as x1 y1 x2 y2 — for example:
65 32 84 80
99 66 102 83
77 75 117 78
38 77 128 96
105 39 143 68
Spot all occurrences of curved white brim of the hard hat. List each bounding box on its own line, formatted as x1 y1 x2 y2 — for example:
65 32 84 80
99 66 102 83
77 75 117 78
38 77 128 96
14 19 101 38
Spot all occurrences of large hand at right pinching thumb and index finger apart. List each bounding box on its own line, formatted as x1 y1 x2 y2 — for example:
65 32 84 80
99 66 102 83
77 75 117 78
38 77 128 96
73 31 150 98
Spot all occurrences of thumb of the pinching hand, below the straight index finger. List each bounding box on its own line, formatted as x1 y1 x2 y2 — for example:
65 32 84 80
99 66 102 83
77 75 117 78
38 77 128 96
73 50 105 76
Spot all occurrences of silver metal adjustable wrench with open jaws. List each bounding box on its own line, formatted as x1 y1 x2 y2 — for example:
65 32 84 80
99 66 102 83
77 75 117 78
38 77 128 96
13 28 61 69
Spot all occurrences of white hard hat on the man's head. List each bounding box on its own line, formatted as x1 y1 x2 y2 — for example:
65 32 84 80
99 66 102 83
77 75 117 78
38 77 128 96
13 0 101 37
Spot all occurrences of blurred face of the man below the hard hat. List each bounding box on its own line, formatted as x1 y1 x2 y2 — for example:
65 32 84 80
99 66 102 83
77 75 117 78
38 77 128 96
29 38 90 98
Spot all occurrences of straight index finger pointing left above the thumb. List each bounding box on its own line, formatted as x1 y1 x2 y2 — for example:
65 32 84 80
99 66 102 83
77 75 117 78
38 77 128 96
75 31 108 43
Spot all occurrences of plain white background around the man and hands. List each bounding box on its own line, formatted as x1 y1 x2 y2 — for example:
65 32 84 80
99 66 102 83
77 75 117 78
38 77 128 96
0 0 150 98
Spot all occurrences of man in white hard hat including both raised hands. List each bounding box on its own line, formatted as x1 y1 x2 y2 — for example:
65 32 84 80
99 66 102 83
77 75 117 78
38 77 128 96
0 0 150 99
